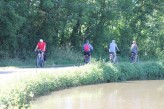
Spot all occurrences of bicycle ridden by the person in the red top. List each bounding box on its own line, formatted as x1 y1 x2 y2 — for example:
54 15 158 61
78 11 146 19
36 49 44 68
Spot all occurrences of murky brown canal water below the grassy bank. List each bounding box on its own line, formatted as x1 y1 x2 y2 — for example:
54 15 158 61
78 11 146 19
32 80 164 109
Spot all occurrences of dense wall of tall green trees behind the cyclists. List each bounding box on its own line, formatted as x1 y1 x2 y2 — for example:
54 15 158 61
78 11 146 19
0 0 164 60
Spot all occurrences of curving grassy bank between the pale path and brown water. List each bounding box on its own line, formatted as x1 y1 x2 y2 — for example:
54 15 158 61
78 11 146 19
0 62 164 109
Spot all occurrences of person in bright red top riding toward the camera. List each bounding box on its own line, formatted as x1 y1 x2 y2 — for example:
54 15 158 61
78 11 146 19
35 39 46 61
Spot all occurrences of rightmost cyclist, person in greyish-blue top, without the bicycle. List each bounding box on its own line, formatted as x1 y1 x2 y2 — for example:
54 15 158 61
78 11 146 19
131 41 138 62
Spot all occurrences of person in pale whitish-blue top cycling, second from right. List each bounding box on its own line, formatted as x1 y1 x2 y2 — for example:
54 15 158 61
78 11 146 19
109 40 119 63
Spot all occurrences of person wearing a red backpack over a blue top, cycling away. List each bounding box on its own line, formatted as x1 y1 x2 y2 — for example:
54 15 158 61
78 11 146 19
82 40 93 61
